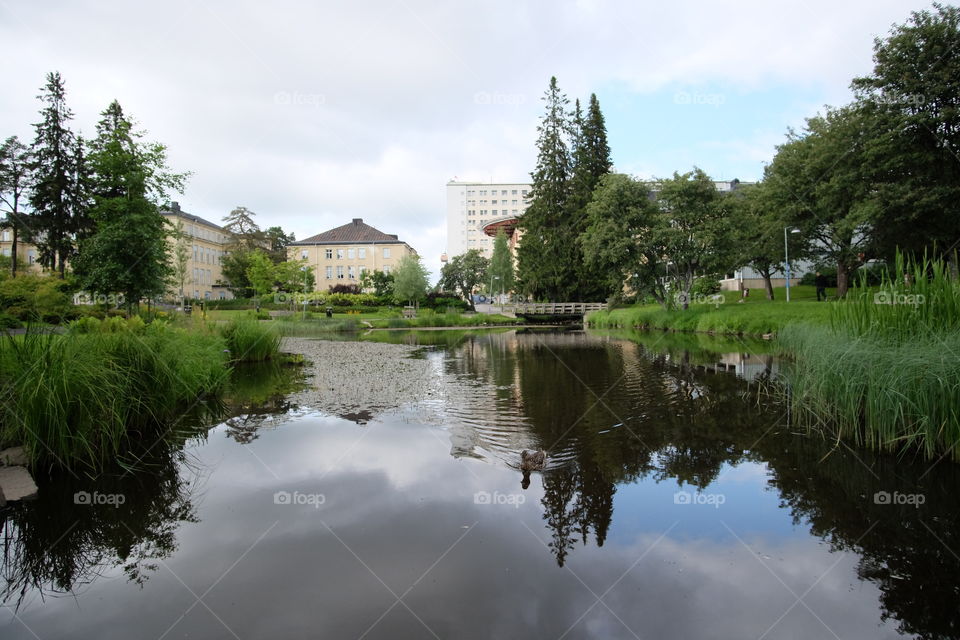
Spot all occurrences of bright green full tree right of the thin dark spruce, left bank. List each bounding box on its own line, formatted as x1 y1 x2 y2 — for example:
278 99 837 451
74 101 184 307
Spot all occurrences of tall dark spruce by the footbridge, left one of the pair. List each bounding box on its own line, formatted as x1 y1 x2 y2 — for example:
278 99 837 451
517 77 576 301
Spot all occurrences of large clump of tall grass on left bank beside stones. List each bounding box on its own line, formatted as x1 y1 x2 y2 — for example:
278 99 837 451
0 320 229 470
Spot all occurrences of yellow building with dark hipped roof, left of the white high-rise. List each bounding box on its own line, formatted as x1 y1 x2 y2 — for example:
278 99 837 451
287 218 417 291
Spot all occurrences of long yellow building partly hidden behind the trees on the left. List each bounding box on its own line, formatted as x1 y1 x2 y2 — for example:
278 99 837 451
160 202 233 300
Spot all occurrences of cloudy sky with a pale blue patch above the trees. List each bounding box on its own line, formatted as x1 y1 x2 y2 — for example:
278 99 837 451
0 0 930 274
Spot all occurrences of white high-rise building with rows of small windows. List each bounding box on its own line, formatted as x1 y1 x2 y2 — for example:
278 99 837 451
447 181 530 258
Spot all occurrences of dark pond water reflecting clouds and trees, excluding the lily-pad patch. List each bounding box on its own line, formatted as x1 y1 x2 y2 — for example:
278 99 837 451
0 331 960 640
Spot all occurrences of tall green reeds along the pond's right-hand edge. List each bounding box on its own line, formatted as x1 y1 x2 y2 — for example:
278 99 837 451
778 256 960 460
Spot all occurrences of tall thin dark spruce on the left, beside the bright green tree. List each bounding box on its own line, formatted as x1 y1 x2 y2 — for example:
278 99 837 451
30 71 83 278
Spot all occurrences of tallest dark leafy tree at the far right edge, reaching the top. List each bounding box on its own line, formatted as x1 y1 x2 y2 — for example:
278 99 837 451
853 3 960 261
